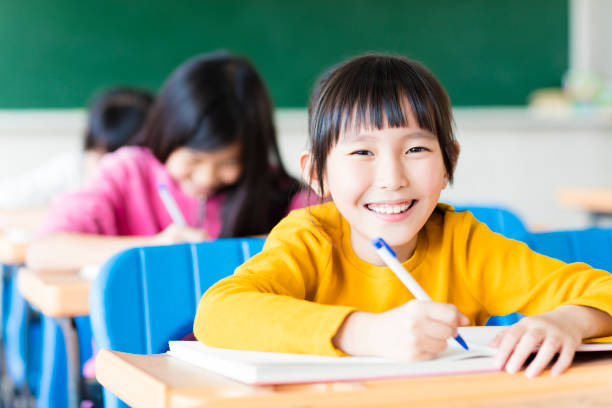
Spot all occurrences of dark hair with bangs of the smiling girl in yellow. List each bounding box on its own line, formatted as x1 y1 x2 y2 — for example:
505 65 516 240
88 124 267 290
308 54 459 195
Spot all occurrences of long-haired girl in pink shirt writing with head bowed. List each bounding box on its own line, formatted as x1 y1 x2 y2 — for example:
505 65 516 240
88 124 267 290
27 53 306 270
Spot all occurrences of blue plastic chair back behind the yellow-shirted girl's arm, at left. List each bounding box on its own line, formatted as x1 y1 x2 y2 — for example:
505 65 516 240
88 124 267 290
89 238 264 407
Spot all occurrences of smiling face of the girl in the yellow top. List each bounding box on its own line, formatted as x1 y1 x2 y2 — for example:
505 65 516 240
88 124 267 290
324 113 448 265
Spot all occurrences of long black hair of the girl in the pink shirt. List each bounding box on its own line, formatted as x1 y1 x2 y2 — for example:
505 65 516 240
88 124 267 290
138 52 300 237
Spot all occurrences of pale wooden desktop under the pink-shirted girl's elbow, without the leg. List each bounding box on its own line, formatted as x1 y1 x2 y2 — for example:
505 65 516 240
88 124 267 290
17 268 91 317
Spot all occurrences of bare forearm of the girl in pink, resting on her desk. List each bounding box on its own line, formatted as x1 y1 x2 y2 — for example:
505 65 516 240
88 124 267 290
26 233 155 271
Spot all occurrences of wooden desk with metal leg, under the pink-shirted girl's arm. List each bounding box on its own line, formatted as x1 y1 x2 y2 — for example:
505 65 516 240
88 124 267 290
17 268 91 408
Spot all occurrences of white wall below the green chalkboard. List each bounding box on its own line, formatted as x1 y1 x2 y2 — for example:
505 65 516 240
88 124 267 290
0 108 612 228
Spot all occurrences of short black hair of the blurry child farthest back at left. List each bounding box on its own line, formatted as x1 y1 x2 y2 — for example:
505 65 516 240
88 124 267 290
84 87 153 152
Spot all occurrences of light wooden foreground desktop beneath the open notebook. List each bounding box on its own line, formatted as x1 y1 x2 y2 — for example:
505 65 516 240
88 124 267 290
96 350 612 408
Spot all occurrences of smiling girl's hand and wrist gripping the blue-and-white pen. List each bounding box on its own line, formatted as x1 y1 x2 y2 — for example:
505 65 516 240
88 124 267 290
334 300 469 361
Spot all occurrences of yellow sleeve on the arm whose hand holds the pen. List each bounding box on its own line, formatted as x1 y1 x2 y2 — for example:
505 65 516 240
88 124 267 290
194 212 353 355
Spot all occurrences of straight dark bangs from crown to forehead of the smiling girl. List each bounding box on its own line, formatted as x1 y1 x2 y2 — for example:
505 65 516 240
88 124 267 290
310 58 444 149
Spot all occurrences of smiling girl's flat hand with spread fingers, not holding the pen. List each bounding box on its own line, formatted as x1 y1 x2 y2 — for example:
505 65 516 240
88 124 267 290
489 313 582 378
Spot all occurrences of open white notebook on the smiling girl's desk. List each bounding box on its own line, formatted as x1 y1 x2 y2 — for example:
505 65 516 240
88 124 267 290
168 326 612 385
